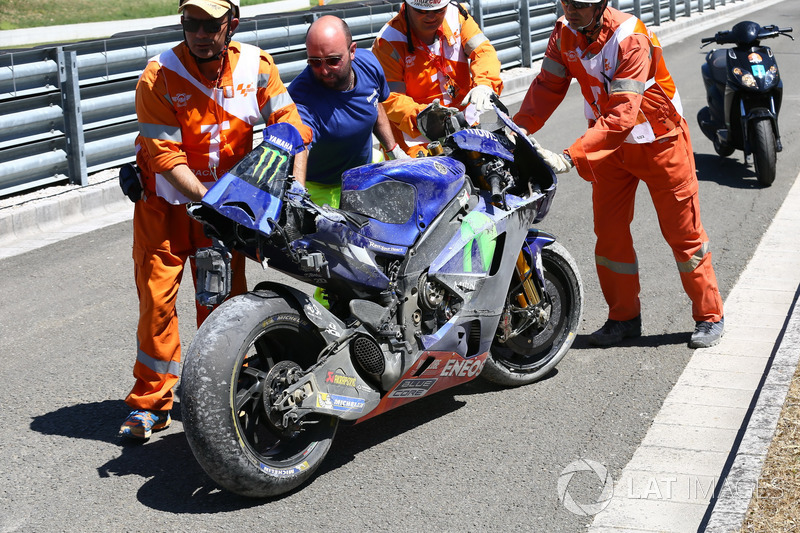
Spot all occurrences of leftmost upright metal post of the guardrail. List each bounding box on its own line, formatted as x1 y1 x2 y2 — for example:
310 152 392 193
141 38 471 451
57 46 89 185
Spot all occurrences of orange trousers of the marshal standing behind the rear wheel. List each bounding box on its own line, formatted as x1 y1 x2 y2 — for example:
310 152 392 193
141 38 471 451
125 195 247 410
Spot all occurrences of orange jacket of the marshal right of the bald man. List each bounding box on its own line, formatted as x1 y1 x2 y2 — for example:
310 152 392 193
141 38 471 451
372 4 503 154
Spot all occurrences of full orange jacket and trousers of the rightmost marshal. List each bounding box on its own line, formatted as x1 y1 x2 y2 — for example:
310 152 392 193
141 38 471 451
514 7 722 322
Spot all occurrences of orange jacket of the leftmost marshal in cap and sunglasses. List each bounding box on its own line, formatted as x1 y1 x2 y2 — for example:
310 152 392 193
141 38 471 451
136 41 311 204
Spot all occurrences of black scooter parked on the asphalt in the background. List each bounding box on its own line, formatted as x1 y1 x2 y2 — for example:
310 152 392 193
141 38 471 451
697 21 794 187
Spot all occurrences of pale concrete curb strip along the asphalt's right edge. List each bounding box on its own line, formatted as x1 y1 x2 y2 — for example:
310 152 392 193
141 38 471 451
589 170 800 533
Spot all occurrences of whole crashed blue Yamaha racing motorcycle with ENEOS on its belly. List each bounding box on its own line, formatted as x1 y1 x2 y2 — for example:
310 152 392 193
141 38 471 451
181 102 584 497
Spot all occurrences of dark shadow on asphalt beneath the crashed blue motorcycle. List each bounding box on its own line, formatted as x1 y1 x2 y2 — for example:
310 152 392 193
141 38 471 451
30 378 540 514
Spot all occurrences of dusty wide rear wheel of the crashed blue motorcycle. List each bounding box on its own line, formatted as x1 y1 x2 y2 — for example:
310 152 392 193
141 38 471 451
181 291 338 498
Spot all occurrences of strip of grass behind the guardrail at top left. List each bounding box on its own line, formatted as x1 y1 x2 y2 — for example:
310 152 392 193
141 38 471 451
0 0 284 31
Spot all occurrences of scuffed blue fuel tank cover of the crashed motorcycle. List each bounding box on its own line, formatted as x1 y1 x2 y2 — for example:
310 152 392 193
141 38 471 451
340 157 465 246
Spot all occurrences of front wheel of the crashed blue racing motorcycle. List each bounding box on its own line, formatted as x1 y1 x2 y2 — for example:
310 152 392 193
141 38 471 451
481 242 584 386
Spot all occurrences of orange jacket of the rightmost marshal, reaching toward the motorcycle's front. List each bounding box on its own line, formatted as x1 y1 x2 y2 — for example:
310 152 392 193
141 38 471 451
514 7 683 181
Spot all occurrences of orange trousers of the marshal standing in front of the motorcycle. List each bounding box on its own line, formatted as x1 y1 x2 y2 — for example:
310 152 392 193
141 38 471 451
592 122 722 322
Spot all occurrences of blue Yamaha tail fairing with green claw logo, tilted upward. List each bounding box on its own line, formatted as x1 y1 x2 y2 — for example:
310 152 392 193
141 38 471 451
203 122 303 235
